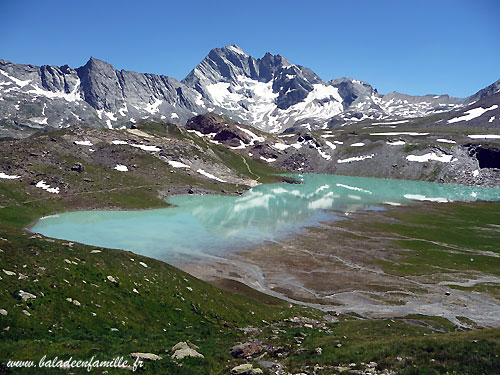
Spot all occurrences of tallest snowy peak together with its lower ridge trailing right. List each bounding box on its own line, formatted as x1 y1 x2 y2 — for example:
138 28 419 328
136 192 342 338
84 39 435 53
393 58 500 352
182 45 467 133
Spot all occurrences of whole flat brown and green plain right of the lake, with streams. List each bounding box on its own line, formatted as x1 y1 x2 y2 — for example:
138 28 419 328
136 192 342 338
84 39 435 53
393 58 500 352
178 203 500 327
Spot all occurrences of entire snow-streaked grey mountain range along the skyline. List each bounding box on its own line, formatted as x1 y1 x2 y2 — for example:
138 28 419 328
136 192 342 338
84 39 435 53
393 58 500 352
0 45 500 138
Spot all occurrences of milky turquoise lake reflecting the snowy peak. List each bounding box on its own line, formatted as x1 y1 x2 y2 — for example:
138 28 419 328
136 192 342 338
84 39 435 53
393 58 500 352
31 175 500 261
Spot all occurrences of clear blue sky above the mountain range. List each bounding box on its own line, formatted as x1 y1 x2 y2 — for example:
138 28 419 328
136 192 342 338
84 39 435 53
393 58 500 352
0 0 500 96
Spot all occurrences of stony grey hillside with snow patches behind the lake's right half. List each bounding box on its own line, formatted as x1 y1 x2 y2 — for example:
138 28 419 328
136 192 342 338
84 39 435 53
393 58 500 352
186 112 500 186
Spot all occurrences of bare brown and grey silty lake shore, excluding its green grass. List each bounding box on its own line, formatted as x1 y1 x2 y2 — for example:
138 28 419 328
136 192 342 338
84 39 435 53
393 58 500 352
175 203 500 327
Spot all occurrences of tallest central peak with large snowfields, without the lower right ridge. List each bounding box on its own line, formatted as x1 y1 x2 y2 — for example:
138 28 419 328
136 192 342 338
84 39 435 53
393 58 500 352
182 46 343 132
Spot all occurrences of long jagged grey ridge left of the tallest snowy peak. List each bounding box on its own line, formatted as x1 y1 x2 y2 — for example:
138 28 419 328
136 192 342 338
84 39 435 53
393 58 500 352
0 58 206 137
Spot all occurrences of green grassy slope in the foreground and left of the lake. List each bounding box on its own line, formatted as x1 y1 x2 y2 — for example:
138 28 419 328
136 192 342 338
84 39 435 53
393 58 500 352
0 125 500 374
